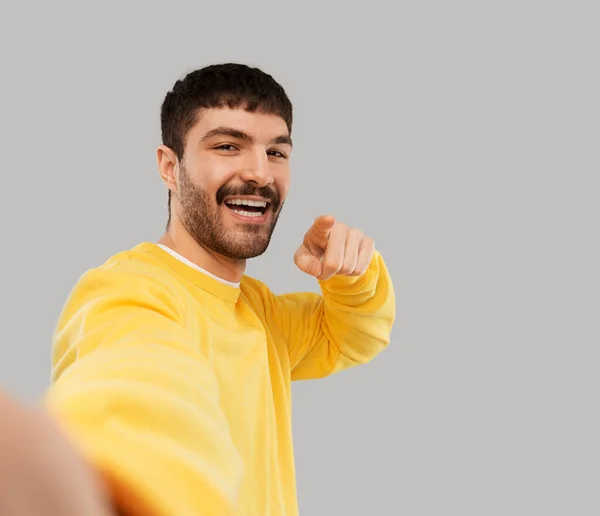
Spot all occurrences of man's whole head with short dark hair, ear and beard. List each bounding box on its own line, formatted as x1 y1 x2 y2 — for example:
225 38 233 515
157 64 292 260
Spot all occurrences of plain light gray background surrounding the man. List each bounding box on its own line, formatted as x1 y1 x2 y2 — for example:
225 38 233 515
0 1 600 516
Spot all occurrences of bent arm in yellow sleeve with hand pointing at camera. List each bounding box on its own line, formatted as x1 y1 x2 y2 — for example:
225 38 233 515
267 216 396 380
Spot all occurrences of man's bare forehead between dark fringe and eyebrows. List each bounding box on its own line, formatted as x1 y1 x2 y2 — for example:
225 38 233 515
190 108 289 141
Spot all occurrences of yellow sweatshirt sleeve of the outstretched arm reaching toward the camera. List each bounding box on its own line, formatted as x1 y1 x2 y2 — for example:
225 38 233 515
44 268 242 516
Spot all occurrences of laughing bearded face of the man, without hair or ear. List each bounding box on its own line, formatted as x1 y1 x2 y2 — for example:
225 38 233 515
178 109 292 259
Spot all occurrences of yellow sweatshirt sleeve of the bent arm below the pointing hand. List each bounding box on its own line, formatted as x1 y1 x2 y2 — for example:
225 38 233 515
264 251 396 380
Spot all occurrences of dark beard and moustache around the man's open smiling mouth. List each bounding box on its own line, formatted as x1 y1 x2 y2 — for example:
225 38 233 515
179 166 283 260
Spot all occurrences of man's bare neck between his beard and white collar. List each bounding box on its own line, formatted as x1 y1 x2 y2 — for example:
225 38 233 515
157 220 246 283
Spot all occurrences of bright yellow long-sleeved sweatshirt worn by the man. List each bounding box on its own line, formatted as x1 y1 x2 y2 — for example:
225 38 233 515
44 242 395 516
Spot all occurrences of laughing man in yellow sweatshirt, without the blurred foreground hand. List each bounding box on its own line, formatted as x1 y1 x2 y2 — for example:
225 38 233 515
0 64 395 516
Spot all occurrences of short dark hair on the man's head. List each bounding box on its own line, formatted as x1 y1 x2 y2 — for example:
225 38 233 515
160 63 292 225
